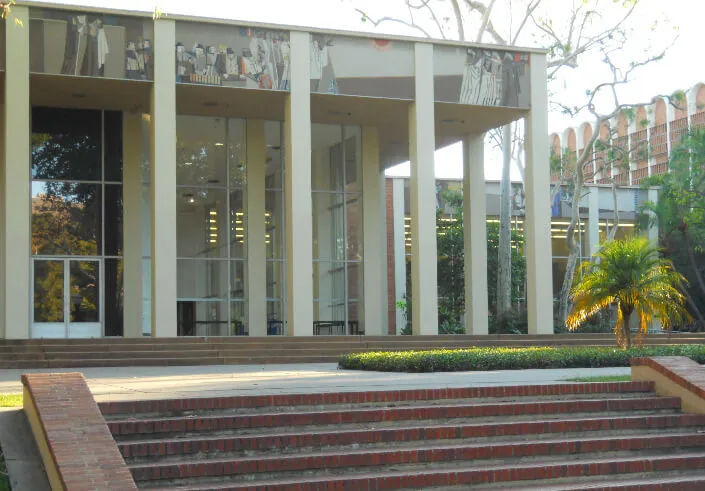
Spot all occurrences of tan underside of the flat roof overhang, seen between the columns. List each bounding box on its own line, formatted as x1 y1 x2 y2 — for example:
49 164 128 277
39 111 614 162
28 73 528 168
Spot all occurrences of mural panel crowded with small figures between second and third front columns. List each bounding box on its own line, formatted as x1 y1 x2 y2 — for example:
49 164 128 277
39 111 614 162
176 22 291 90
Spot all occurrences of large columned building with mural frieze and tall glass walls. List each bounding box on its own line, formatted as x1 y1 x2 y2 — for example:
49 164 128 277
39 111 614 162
0 2 552 339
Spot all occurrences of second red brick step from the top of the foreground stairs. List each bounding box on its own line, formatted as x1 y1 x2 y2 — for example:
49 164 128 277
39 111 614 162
108 397 680 436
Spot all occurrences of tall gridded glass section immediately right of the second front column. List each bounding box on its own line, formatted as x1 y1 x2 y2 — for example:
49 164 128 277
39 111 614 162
176 116 248 336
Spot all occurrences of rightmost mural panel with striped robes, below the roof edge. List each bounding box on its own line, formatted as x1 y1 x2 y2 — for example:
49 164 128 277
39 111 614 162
433 46 531 107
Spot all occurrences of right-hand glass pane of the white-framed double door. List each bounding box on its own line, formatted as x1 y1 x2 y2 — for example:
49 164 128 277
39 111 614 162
69 261 101 322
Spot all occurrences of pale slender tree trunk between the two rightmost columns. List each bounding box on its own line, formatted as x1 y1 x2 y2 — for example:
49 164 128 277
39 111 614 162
497 124 512 317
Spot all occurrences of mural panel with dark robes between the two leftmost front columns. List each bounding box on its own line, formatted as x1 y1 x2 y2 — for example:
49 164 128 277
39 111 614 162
29 8 154 80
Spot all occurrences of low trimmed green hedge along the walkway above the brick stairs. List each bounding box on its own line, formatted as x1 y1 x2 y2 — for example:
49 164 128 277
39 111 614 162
338 345 705 372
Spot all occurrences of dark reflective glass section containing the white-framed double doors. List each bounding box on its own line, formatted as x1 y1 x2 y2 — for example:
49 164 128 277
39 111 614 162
31 107 123 337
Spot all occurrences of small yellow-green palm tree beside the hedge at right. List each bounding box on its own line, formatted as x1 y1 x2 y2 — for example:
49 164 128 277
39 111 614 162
566 237 690 348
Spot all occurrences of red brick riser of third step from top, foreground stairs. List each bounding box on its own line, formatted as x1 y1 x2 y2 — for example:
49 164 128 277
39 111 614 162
118 415 705 461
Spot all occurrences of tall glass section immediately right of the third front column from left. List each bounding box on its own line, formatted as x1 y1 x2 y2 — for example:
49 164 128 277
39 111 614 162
311 124 364 335
